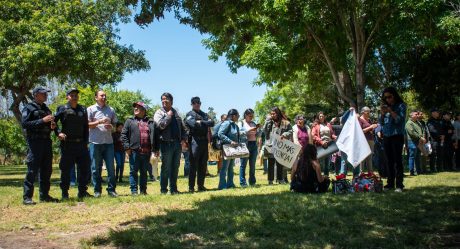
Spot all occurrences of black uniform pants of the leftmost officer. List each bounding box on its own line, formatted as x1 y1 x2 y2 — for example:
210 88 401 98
23 139 52 199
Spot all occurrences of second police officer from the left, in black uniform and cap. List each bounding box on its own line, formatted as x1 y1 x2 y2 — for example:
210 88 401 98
55 88 91 200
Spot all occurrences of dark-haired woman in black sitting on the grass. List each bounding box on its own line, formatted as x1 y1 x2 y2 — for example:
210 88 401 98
291 144 330 193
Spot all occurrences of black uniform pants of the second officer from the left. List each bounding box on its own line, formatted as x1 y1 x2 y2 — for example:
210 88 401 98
59 142 91 193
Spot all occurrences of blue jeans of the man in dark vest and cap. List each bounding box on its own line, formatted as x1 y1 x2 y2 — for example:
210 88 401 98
129 151 150 193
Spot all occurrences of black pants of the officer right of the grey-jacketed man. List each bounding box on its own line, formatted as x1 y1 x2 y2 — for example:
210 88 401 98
188 138 208 190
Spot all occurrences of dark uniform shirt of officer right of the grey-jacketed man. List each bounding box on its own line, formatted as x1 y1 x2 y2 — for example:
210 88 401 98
185 110 214 140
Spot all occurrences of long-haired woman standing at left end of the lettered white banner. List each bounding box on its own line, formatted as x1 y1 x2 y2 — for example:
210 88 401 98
263 106 292 185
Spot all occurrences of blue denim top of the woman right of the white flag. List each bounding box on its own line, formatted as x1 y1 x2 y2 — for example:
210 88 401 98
379 103 407 137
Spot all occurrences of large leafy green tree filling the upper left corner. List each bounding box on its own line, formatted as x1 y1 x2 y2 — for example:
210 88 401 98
0 0 149 124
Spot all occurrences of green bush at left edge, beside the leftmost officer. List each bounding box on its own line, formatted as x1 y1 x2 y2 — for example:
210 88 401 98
0 119 27 164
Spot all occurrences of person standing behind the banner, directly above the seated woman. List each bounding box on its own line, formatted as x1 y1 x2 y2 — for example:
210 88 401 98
311 112 337 175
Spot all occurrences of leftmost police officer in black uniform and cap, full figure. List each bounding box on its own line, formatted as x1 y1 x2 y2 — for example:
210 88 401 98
22 87 58 205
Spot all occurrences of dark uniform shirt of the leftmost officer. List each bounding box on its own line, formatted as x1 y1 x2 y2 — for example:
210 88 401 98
22 101 51 140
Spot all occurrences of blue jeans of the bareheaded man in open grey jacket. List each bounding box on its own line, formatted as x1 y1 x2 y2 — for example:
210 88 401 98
160 141 182 193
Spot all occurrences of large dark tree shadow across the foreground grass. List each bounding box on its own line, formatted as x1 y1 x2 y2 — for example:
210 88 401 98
83 187 460 248
